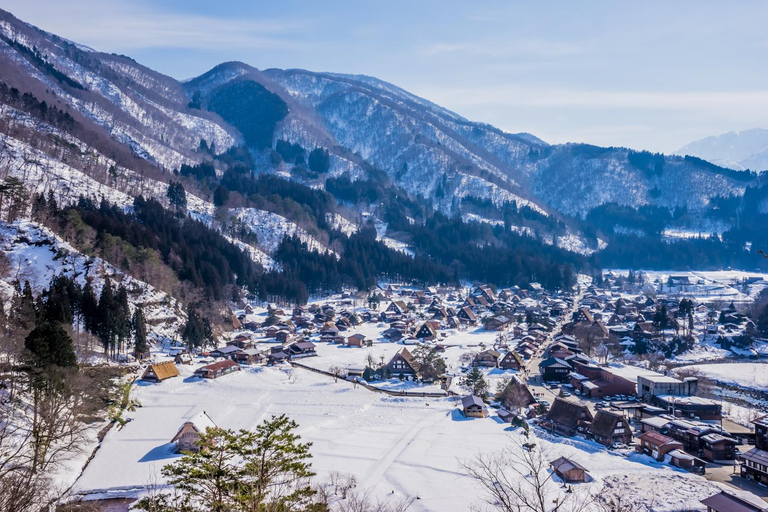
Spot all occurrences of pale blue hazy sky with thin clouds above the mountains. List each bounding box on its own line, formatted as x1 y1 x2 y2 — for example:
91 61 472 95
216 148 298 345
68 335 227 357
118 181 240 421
6 0 768 152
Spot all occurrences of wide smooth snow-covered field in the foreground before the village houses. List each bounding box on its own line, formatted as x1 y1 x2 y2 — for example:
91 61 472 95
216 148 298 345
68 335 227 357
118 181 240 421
69 367 717 511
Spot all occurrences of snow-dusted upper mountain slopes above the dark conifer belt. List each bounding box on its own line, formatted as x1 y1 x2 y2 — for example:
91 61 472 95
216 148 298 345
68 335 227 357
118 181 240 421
0 5 750 276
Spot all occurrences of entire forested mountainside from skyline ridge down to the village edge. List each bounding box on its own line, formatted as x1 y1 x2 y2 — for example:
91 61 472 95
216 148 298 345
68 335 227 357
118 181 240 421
0 6 767 340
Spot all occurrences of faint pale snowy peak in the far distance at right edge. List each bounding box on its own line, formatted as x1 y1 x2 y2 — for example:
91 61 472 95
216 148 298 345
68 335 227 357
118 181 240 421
677 128 768 171
